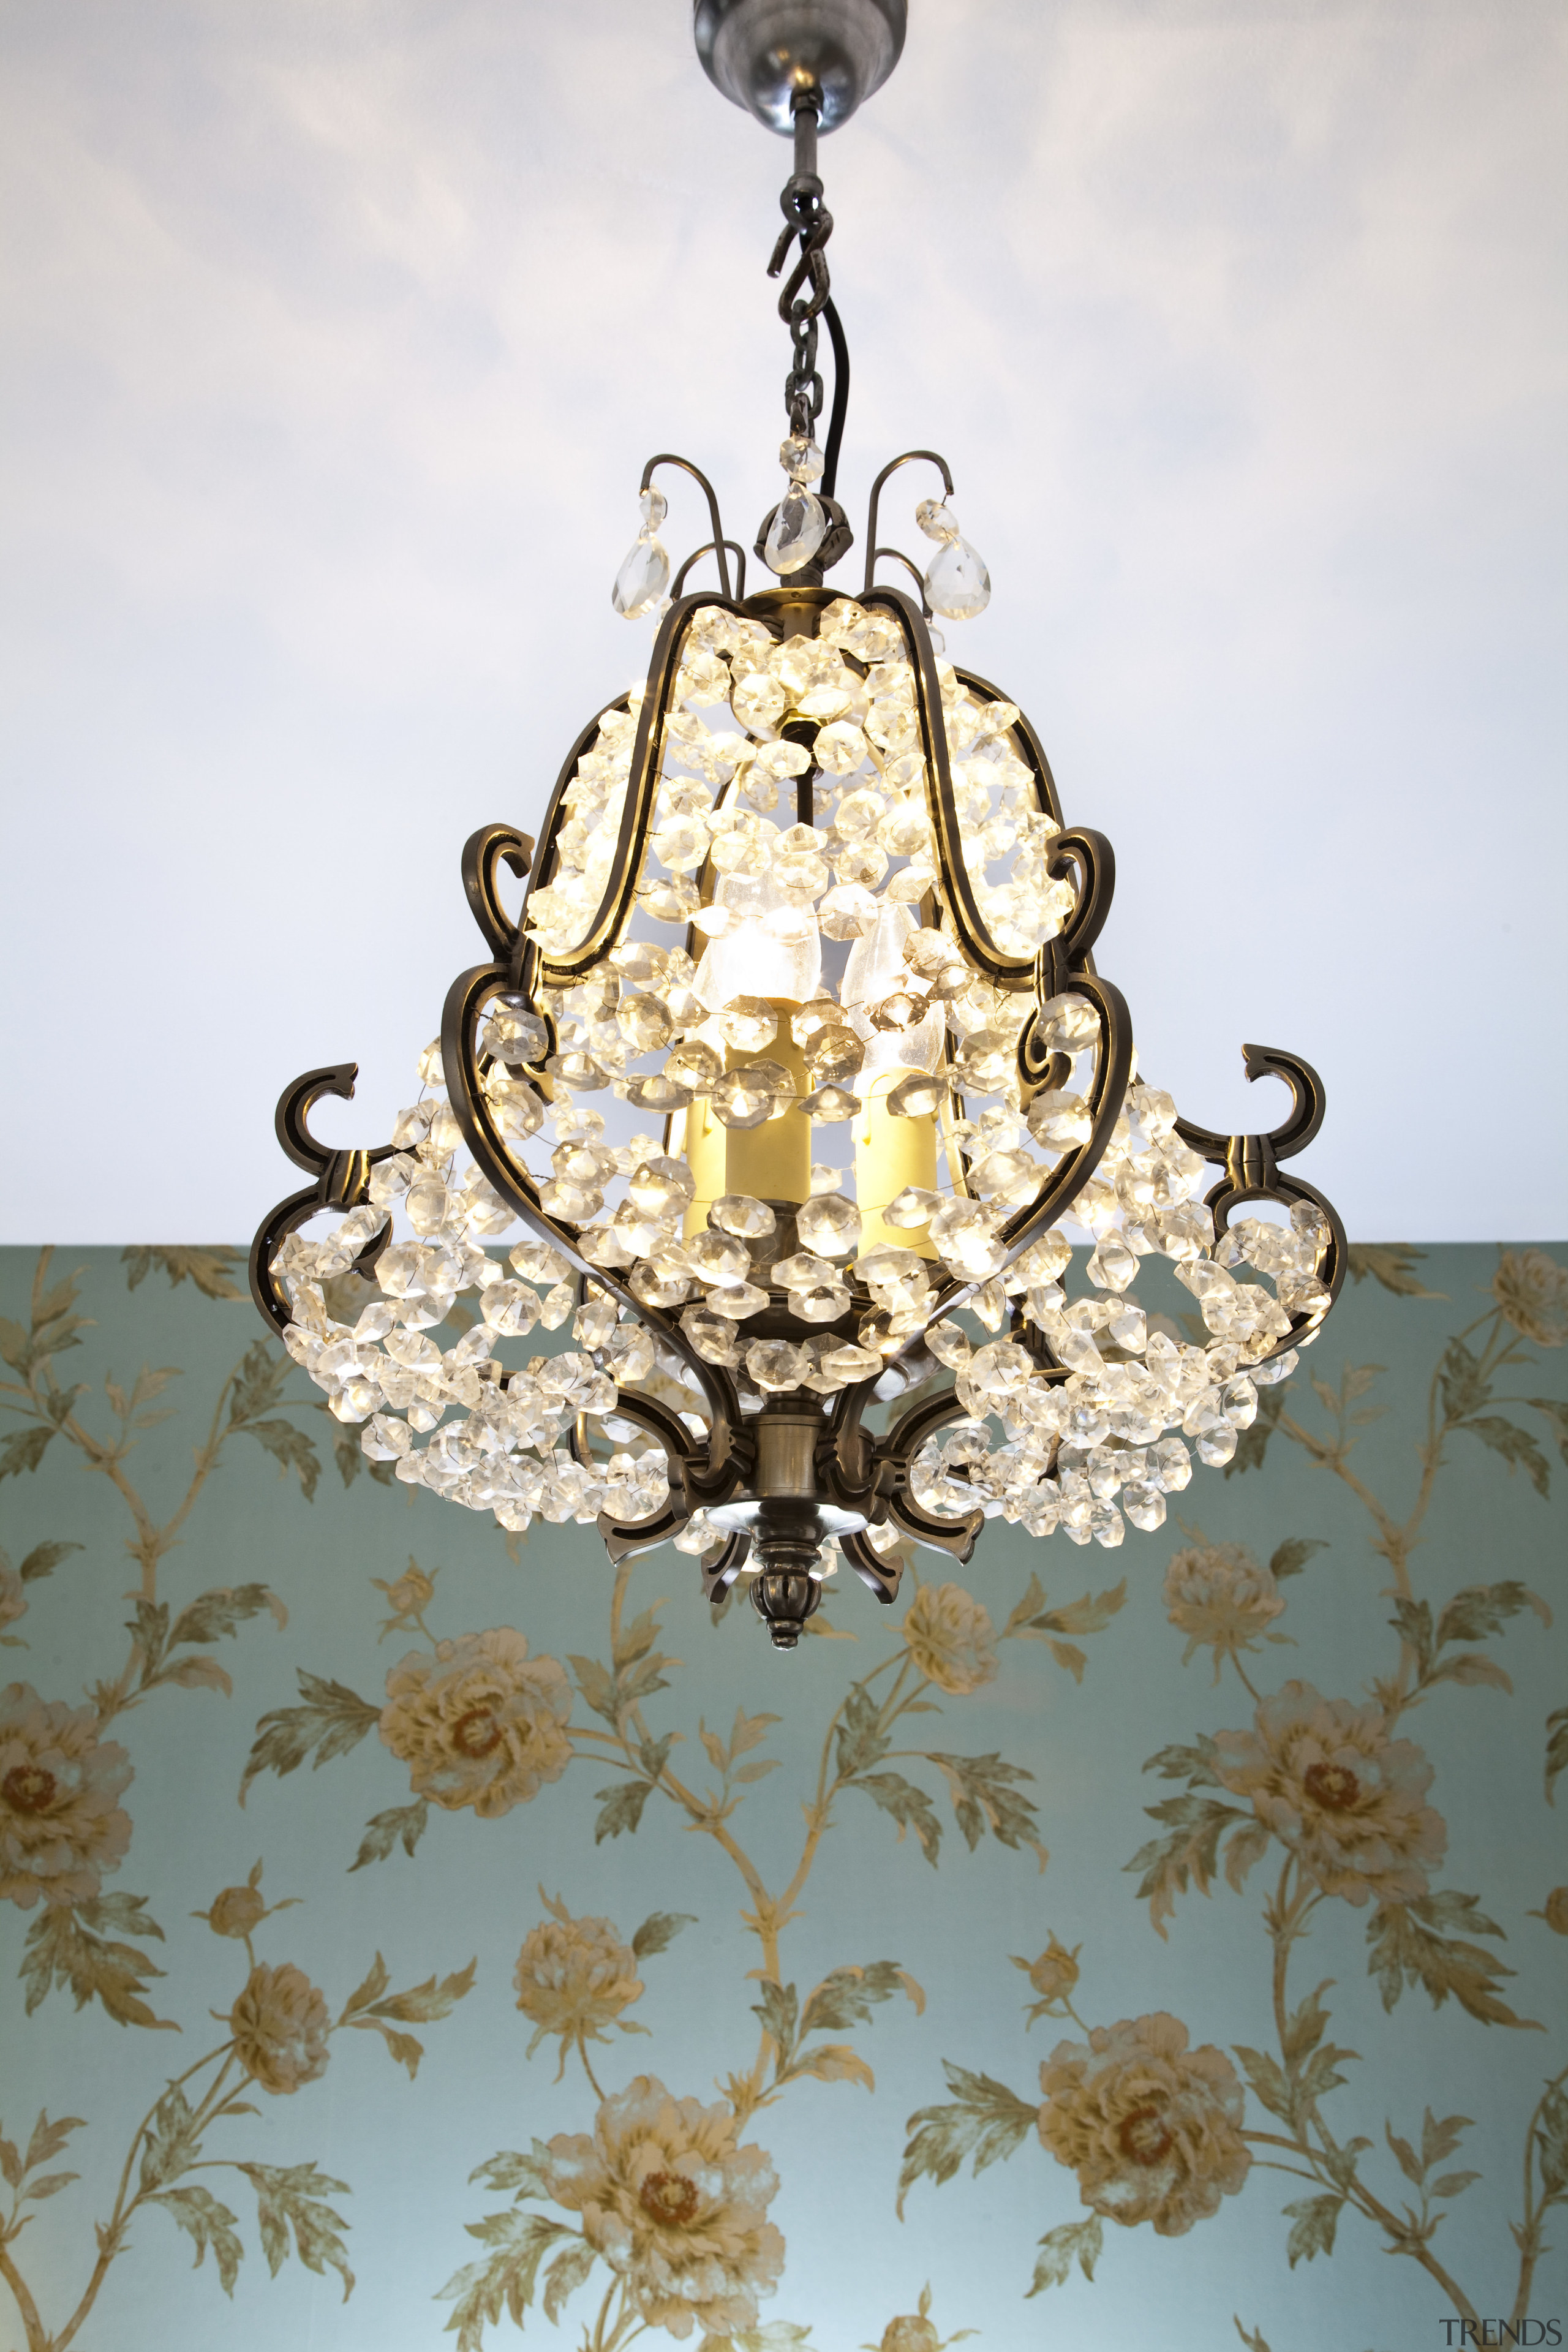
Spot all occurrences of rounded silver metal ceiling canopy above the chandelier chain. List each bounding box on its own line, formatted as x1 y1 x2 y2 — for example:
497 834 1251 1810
693 0 907 137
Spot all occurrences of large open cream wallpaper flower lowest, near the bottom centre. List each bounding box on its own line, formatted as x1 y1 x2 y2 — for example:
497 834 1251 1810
545 2075 785 2335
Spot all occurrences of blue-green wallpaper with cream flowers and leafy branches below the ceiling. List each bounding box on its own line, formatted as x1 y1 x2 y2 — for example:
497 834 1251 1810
0 1246 1568 2352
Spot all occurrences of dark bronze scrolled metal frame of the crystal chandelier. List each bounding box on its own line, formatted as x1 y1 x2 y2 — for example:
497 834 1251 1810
252 472 1344 1602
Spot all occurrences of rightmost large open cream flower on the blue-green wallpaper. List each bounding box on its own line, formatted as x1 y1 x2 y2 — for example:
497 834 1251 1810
1215 1682 1448 1903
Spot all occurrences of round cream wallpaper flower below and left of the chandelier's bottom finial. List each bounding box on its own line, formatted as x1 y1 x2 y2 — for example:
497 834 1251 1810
381 1625 571 1820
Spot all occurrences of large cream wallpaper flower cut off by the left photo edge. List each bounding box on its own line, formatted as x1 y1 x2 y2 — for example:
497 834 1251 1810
0 1682 132 1910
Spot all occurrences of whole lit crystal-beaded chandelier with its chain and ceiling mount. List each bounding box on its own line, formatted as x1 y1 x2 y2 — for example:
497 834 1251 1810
252 0 1344 1649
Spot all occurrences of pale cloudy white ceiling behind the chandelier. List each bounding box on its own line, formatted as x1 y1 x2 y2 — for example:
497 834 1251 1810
0 0 1568 1242
